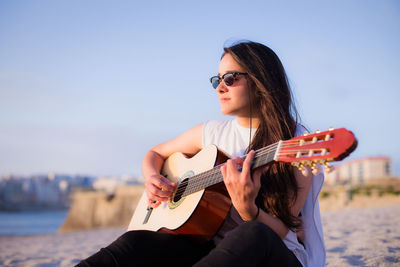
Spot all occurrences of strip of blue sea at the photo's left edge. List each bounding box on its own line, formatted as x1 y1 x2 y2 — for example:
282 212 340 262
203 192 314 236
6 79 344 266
0 211 68 236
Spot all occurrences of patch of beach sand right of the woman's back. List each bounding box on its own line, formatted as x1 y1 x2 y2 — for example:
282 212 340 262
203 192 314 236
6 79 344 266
322 205 400 266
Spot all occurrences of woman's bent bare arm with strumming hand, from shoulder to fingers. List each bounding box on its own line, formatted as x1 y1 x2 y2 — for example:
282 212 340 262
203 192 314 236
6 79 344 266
142 124 203 208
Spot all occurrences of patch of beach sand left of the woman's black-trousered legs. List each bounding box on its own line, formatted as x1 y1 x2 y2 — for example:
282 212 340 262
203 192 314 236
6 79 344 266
0 228 124 267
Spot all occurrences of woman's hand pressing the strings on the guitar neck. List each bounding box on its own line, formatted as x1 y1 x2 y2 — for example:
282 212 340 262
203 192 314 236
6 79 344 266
221 150 266 221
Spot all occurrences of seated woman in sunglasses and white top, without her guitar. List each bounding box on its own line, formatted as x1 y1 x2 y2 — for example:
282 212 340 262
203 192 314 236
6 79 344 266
80 42 325 266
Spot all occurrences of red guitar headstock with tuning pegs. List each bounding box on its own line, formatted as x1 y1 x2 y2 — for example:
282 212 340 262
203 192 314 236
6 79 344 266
277 128 357 173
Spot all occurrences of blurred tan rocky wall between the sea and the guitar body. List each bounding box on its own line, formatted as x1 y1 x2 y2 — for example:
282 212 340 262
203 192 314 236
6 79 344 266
59 185 144 232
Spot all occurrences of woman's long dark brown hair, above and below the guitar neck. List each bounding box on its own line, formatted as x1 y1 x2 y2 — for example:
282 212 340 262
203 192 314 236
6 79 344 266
224 41 301 230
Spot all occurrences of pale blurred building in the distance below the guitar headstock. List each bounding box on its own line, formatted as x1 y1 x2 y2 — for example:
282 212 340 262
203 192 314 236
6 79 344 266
325 157 393 185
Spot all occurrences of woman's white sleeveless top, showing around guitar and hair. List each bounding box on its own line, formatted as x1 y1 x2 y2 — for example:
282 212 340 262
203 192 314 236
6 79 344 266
202 119 325 267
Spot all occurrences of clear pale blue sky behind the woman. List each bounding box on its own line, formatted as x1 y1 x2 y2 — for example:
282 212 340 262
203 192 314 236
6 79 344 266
0 0 400 176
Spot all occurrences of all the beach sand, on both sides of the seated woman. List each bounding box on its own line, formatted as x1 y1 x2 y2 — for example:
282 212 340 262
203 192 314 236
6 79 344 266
0 205 400 267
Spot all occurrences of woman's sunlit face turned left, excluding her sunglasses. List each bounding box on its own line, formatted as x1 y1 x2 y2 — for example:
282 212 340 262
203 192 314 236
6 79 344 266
216 54 250 117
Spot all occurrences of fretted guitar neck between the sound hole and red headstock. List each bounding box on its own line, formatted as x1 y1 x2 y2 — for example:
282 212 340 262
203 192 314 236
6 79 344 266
182 141 283 197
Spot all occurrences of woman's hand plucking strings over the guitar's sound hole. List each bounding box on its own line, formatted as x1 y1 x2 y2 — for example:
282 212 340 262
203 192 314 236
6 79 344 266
145 174 177 208
